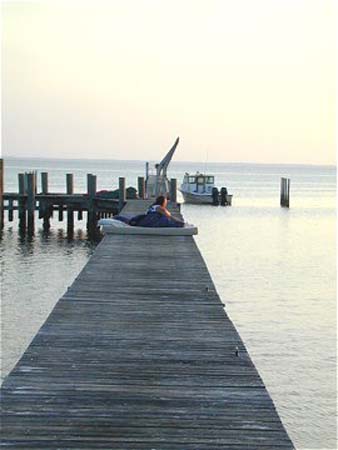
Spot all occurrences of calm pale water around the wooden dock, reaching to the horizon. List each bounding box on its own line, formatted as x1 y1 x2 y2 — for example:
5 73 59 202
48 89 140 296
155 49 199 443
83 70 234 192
0 159 337 449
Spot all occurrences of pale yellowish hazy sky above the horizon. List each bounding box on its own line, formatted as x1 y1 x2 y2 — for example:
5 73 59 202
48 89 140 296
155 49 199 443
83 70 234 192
2 0 336 164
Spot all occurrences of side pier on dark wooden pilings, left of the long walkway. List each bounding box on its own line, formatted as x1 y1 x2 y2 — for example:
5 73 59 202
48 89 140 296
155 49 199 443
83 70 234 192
0 161 177 235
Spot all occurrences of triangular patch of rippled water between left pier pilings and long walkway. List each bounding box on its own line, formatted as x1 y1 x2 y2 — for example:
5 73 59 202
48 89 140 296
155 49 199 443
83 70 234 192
0 223 100 378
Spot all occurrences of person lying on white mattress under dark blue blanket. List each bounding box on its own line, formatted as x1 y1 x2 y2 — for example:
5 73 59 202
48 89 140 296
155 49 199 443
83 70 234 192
114 195 184 228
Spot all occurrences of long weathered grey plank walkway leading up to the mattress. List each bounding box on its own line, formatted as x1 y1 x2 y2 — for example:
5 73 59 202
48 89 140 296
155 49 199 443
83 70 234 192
2 201 293 450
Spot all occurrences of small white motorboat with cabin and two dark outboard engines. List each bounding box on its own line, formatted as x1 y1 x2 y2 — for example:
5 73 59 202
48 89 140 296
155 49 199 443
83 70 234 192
179 172 232 206
